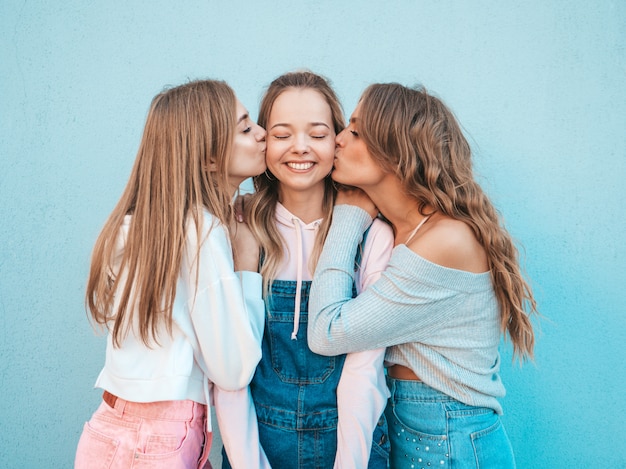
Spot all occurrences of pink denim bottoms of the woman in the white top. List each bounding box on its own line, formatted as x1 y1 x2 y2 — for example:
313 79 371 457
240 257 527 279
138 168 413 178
74 395 213 469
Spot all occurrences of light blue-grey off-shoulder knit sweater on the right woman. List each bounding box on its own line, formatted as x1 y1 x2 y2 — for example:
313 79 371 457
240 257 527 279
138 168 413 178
308 205 505 413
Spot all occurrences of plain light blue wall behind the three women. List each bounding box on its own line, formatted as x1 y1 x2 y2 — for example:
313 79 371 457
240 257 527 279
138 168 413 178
0 0 626 468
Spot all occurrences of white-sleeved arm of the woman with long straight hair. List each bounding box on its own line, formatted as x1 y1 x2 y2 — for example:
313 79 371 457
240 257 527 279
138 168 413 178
181 214 265 390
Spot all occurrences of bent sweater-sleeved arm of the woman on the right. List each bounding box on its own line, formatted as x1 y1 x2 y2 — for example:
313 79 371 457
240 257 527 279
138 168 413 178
308 205 462 355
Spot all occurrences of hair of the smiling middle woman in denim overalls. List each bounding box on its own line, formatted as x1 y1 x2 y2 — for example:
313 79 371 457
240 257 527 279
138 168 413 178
247 71 345 293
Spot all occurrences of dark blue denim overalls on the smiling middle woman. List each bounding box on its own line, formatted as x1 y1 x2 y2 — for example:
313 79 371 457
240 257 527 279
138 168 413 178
223 280 389 469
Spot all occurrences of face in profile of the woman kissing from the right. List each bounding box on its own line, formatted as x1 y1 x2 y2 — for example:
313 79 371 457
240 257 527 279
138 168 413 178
332 103 385 189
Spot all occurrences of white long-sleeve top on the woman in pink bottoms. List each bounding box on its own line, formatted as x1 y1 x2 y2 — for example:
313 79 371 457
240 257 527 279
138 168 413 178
95 210 265 429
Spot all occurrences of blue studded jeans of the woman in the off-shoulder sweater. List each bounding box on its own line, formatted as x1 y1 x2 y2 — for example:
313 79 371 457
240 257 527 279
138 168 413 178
385 376 515 469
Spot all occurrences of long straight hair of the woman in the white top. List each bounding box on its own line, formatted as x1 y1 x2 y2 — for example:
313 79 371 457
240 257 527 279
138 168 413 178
86 80 236 346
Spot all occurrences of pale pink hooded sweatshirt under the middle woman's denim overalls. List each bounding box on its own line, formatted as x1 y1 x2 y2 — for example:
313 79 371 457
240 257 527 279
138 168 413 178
214 203 393 469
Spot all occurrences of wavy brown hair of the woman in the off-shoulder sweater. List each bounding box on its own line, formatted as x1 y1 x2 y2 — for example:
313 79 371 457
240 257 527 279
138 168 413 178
359 83 538 361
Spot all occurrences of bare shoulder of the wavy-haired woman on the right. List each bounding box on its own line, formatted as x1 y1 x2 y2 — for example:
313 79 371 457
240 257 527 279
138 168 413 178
408 215 489 273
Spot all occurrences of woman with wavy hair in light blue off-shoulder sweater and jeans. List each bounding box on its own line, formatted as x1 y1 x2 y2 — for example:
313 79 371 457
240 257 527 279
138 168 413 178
308 84 537 468
